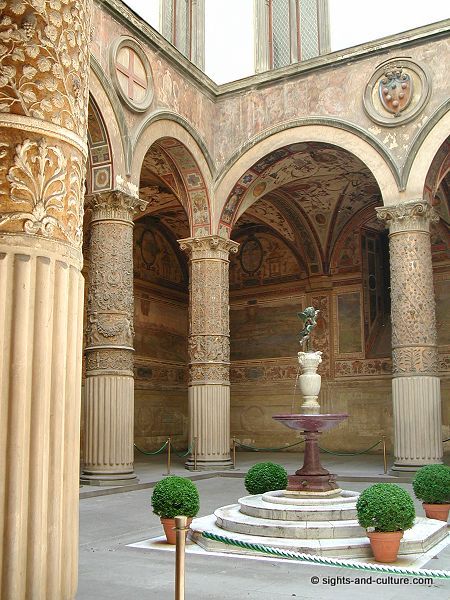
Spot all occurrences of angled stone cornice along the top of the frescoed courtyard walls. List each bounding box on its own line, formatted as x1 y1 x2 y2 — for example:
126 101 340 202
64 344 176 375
96 0 450 99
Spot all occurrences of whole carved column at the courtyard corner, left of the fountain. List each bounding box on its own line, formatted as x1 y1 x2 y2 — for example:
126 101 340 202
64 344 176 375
179 236 238 470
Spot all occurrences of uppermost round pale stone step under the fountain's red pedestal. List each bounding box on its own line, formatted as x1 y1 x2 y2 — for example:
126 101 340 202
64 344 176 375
238 494 356 521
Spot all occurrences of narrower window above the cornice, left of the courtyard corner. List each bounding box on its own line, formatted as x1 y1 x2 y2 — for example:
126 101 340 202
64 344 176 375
160 0 205 69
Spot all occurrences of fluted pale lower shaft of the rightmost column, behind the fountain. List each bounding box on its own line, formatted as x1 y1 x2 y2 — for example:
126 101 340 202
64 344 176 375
392 376 443 471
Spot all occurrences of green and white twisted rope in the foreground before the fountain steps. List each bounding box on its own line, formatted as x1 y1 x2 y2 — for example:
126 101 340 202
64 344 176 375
202 531 450 579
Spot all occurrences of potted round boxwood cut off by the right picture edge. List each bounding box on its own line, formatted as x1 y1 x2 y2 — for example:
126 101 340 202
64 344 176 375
413 465 450 522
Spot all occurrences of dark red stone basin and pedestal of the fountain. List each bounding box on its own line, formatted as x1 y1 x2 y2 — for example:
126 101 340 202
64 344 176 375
272 413 348 498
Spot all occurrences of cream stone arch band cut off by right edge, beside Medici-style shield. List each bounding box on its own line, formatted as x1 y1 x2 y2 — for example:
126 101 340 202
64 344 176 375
405 103 450 202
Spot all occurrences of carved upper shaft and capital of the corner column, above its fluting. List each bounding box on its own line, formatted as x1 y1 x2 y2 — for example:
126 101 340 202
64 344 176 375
179 236 238 385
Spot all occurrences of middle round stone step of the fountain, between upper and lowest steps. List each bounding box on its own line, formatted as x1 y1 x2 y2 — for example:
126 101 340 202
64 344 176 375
214 504 365 540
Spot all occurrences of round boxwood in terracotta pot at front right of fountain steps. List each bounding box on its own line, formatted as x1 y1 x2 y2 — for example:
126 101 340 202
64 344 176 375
356 483 416 563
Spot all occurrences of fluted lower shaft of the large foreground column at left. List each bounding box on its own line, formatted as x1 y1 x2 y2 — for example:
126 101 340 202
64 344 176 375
0 235 84 600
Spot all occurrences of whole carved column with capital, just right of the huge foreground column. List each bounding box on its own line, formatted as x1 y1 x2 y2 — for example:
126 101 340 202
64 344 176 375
81 190 147 485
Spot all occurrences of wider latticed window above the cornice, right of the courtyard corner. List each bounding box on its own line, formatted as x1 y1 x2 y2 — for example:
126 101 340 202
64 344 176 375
255 0 330 73
